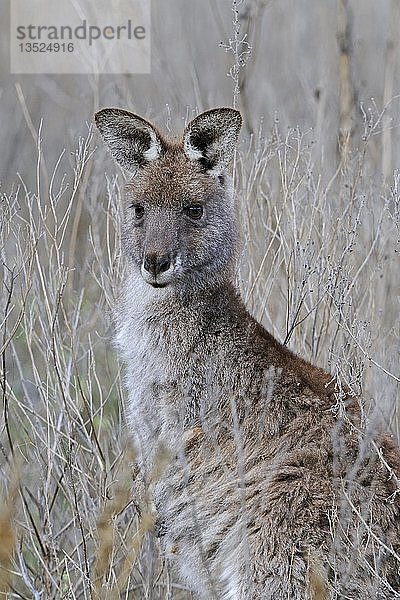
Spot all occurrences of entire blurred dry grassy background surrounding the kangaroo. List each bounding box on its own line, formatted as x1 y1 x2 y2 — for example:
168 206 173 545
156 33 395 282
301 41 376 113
0 0 400 600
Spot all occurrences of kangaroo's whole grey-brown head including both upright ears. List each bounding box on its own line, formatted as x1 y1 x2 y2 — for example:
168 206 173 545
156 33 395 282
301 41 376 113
95 108 241 288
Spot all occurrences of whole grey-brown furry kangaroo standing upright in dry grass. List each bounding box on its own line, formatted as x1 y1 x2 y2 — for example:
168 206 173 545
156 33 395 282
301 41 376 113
95 108 400 600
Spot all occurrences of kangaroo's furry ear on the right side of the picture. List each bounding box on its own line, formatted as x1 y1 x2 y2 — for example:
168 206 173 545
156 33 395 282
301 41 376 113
183 108 242 175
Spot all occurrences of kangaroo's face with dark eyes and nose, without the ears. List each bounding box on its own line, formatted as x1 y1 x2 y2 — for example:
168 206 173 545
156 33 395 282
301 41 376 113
123 149 235 287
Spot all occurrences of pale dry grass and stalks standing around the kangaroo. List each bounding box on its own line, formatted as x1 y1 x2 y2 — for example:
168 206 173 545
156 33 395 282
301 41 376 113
0 2 400 600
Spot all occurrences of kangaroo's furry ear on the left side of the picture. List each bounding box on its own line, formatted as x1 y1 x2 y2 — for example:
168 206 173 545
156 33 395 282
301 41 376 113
94 108 163 173
